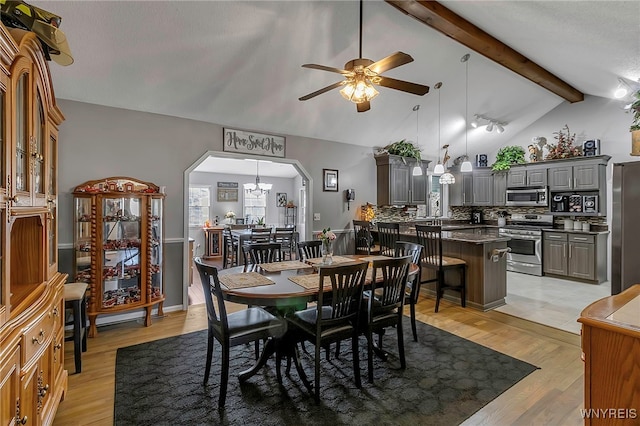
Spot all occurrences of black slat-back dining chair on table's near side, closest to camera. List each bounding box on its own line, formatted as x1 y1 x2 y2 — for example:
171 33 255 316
287 262 368 402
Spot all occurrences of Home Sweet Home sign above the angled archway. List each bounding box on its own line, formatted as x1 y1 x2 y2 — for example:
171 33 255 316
222 128 285 158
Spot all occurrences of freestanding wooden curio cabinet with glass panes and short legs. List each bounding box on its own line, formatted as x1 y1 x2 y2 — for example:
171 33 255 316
73 177 165 337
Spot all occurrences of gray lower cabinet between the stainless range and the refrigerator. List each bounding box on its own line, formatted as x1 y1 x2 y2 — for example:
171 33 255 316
542 231 607 283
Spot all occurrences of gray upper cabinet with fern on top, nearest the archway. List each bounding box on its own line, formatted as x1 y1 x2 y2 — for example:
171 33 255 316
375 154 430 206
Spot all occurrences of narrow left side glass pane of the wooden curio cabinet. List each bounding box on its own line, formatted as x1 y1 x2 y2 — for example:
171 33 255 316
73 197 92 283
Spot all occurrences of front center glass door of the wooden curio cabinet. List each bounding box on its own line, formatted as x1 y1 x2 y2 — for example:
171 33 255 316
101 197 144 308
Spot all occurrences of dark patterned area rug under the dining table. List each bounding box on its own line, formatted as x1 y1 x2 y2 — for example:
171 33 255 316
115 318 536 425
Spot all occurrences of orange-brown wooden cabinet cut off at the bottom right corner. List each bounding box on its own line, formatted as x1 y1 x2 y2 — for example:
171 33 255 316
578 284 640 425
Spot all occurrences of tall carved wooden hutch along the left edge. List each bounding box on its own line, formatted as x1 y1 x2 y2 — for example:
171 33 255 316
0 24 67 425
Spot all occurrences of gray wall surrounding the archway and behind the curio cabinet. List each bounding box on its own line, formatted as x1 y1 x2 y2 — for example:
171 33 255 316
58 99 376 307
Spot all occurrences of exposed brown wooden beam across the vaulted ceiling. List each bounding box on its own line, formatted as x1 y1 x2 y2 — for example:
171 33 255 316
385 0 584 103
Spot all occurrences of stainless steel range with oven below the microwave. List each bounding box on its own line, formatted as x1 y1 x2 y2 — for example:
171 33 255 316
498 214 553 276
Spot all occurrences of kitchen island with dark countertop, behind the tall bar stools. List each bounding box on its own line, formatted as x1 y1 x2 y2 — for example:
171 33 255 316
400 225 510 311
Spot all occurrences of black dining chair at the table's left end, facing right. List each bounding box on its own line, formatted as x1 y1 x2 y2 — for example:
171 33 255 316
194 257 286 408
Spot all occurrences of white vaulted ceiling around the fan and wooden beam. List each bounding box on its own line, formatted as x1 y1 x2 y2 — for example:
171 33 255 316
31 0 640 175
